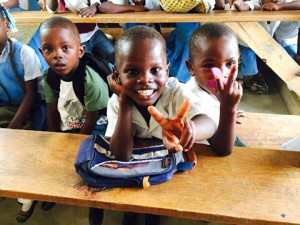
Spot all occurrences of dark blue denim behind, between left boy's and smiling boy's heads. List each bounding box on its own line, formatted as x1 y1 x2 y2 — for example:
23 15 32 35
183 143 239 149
82 29 115 64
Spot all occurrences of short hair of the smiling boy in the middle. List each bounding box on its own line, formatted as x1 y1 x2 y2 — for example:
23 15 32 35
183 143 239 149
115 26 166 65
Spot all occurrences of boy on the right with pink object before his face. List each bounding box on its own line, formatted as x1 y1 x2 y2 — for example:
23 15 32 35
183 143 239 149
186 23 245 149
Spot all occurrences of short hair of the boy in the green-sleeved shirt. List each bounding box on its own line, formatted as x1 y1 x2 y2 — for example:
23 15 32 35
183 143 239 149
40 16 80 42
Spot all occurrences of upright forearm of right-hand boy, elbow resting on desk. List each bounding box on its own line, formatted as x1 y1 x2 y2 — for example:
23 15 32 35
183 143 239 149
210 105 236 156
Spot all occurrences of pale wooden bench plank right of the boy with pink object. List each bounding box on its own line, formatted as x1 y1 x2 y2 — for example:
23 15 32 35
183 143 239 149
237 112 300 150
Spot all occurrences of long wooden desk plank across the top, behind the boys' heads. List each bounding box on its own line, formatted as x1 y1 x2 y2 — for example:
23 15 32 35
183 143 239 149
11 10 300 23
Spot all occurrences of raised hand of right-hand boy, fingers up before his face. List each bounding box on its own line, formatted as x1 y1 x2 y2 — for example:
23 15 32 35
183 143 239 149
216 66 243 111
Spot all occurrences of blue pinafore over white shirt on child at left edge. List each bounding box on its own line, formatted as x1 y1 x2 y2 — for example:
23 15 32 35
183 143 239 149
0 42 25 106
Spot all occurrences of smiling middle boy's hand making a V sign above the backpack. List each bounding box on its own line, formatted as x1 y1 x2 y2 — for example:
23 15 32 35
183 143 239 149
148 100 196 151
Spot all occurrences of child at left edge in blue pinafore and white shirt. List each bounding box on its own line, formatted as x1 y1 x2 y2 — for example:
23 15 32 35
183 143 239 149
0 3 46 222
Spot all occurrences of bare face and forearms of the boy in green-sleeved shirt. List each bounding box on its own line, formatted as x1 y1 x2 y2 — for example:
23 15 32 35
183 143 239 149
40 26 98 134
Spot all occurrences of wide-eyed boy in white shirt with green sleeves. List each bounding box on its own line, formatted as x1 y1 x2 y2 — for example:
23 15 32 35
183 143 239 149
40 16 109 225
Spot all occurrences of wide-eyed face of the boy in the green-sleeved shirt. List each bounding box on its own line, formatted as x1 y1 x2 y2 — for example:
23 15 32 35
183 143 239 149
40 27 84 76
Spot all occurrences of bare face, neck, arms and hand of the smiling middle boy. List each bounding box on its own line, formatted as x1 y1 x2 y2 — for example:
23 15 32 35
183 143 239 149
110 39 216 161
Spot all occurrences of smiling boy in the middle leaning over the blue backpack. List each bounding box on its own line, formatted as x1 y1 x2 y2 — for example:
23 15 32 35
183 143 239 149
105 26 237 225
